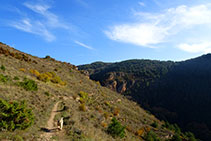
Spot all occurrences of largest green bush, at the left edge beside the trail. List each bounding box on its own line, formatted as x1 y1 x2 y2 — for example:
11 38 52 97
0 99 34 131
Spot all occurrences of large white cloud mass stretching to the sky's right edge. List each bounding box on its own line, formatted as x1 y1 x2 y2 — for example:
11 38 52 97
105 4 211 52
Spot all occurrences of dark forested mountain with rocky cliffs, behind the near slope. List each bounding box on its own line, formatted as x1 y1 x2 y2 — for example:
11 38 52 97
78 54 211 141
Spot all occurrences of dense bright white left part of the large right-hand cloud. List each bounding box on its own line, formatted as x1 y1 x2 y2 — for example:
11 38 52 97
105 24 166 46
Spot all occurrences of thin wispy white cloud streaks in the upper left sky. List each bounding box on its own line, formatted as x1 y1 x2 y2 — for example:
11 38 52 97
9 2 70 42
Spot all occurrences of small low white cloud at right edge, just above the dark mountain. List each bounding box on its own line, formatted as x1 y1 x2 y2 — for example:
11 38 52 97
178 42 211 53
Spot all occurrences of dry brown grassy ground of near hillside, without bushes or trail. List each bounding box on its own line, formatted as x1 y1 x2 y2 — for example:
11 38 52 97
0 44 170 140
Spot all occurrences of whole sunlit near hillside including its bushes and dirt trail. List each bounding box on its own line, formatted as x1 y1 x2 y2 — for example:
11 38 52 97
0 43 186 141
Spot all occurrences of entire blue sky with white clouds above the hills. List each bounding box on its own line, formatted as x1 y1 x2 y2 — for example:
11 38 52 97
0 0 211 65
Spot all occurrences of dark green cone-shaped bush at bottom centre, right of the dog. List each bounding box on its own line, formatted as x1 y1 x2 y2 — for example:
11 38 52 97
107 118 125 138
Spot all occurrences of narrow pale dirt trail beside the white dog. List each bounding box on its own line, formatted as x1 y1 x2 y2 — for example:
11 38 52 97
41 101 61 141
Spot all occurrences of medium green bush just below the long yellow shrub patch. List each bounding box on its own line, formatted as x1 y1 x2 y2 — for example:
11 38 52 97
19 78 38 91
